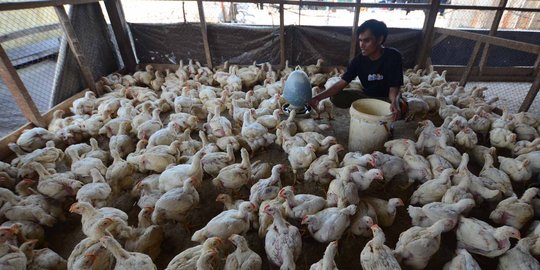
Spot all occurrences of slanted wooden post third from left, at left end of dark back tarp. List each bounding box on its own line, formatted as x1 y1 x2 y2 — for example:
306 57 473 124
105 0 137 73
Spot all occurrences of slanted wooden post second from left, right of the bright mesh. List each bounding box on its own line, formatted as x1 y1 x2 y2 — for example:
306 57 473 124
54 6 101 96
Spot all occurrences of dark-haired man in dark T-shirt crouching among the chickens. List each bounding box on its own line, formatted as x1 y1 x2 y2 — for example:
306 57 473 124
309 20 406 120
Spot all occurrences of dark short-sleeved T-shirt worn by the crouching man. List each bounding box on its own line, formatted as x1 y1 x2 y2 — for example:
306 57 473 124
341 48 403 97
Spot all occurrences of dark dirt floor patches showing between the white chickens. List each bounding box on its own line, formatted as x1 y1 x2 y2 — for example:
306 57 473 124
32 106 521 270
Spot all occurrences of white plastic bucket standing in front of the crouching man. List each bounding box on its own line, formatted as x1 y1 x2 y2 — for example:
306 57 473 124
349 98 392 154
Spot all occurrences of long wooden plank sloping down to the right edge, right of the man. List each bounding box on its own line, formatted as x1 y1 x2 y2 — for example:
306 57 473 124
435 28 540 54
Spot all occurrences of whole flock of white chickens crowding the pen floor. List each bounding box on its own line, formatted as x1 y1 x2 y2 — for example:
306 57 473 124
0 57 540 270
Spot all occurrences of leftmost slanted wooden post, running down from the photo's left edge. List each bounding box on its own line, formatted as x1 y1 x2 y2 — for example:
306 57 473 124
0 45 47 127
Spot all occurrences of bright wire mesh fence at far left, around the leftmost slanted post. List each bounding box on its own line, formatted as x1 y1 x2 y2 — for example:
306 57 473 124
0 7 63 136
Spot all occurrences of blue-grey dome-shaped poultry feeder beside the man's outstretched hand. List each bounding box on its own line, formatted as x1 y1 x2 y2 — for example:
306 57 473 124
282 67 312 117
